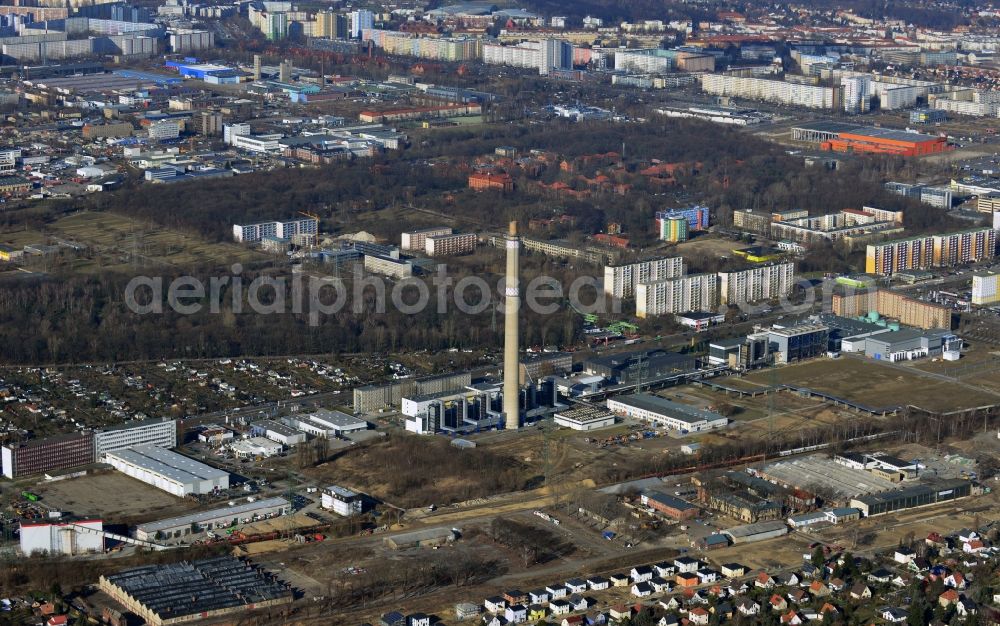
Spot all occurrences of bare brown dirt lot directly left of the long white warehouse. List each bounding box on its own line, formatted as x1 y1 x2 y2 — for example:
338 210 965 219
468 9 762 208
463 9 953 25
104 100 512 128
34 472 197 523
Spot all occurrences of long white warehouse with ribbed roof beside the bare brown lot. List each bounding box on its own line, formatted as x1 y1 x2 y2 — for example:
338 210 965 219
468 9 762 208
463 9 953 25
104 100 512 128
104 445 229 498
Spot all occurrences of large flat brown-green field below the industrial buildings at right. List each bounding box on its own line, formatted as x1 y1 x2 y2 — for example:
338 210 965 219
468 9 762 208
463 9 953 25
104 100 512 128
742 358 1000 411
